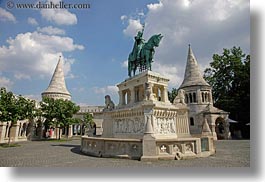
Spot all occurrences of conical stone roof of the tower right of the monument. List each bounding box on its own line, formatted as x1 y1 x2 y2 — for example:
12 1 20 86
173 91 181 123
180 45 210 88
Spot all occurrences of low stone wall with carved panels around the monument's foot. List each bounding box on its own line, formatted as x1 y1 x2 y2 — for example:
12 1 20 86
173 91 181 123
81 136 215 161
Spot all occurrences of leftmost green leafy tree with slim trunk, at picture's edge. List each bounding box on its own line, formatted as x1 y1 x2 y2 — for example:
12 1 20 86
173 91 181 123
0 88 35 144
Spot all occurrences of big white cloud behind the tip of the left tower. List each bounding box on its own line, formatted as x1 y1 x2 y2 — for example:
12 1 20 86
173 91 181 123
0 32 84 79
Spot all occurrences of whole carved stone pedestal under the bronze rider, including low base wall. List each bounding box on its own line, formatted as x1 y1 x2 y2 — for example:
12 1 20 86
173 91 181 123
81 71 212 161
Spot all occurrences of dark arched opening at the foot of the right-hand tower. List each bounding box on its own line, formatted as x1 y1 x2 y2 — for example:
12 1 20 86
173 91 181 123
215 117 229 140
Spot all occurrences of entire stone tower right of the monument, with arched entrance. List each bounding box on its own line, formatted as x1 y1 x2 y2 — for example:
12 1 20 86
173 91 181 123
179 45 230 139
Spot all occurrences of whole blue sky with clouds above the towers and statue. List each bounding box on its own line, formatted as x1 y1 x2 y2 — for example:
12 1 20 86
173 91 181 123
0 0 250 105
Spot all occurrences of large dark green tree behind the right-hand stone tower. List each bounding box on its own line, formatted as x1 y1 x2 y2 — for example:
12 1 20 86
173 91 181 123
204 47 250 124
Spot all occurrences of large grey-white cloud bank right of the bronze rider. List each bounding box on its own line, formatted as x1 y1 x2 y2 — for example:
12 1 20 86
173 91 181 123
132 0 250 87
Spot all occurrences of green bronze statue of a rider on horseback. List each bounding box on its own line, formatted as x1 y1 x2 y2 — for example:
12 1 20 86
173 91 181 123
128 28 163 77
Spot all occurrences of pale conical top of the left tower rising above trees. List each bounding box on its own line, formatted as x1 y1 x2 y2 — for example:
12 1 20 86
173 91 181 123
41 56 71 100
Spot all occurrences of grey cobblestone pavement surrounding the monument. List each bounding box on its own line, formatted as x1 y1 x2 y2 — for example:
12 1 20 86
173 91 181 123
0 140 250 167
